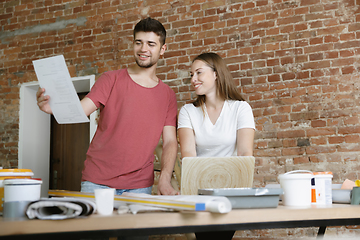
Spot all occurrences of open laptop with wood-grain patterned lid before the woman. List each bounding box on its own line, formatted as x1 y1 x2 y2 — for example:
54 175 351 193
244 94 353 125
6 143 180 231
181 156 255 195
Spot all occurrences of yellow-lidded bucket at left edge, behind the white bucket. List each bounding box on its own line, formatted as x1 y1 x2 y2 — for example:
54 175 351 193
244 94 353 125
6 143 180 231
0 169 34 212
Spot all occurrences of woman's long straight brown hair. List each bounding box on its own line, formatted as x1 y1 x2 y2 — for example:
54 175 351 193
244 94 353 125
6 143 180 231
192 52 245 107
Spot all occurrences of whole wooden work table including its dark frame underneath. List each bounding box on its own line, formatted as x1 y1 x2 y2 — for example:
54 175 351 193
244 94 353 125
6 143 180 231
0 204 360 240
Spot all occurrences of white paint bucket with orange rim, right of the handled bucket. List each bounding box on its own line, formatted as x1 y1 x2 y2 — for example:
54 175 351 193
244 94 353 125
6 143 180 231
313 172 333 205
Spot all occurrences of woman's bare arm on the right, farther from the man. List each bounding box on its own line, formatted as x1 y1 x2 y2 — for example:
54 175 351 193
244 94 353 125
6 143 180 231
236 128 255 156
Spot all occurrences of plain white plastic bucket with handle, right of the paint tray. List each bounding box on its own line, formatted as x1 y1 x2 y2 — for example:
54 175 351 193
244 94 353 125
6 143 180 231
279 170 313 207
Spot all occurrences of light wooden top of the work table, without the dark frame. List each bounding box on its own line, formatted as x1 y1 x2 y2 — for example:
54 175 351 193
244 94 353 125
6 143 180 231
0 204 360 236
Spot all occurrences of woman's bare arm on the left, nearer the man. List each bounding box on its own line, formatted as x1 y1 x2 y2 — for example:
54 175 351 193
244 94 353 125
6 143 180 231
178 128 196 158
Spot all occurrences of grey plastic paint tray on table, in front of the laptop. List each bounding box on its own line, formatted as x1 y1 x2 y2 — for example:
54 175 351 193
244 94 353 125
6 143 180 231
198 188 283 209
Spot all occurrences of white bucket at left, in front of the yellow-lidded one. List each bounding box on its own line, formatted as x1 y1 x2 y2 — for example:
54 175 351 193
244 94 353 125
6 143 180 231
4 179 42 203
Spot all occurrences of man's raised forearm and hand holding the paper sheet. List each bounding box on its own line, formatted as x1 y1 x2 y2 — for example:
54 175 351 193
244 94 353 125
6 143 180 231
36 88 97 116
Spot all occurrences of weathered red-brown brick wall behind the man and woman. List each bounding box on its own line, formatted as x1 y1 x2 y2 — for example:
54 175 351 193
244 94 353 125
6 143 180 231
0 0 360 236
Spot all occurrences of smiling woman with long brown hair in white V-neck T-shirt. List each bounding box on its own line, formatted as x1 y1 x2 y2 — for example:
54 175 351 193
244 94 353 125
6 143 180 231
178 53 255 240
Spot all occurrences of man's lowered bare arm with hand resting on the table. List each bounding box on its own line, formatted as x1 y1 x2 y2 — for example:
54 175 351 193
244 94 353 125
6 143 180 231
157 126 179 195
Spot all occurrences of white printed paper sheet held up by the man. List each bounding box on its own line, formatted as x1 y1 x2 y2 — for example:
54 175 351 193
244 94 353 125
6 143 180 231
33 55 89 124
